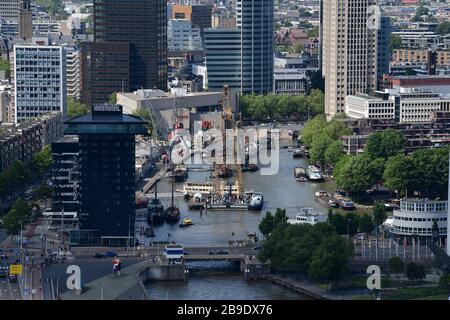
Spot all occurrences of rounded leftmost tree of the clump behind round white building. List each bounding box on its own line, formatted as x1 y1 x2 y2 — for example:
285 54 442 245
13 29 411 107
333 154 384 194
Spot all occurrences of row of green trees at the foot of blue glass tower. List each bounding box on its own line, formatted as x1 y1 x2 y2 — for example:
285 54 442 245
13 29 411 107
239 90 325 121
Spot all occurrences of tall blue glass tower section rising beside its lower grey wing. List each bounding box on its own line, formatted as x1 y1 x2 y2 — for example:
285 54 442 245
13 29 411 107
236 0 274 94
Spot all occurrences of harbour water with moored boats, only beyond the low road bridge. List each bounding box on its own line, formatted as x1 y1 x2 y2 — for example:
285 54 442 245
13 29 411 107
142 125 335 246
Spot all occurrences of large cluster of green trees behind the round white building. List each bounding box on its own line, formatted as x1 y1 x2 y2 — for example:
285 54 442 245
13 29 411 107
333 129 450 198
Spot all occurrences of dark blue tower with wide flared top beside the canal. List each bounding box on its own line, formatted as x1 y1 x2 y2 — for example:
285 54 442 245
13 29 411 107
64 104 147 247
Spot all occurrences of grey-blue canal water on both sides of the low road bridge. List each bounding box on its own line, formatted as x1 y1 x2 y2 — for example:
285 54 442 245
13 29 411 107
142 125 335 300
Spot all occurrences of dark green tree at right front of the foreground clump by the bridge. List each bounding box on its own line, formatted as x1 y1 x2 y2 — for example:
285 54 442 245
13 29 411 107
308 235 353 284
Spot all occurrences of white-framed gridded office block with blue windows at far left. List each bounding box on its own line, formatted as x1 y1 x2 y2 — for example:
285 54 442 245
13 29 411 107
13 39 67 123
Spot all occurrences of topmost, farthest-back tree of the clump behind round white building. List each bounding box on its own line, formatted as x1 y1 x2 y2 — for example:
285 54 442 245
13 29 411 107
364 129 406 159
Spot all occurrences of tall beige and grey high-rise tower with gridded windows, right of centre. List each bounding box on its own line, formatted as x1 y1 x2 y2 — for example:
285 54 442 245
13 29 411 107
322 0 378 119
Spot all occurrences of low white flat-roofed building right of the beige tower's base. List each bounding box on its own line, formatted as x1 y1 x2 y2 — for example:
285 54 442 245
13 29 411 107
345 91 450 124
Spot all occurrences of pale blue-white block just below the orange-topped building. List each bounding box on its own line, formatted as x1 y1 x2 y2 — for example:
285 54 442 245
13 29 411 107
167 19 203 51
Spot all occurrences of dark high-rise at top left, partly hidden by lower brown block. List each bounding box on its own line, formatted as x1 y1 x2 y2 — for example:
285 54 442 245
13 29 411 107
94 0 167 90
